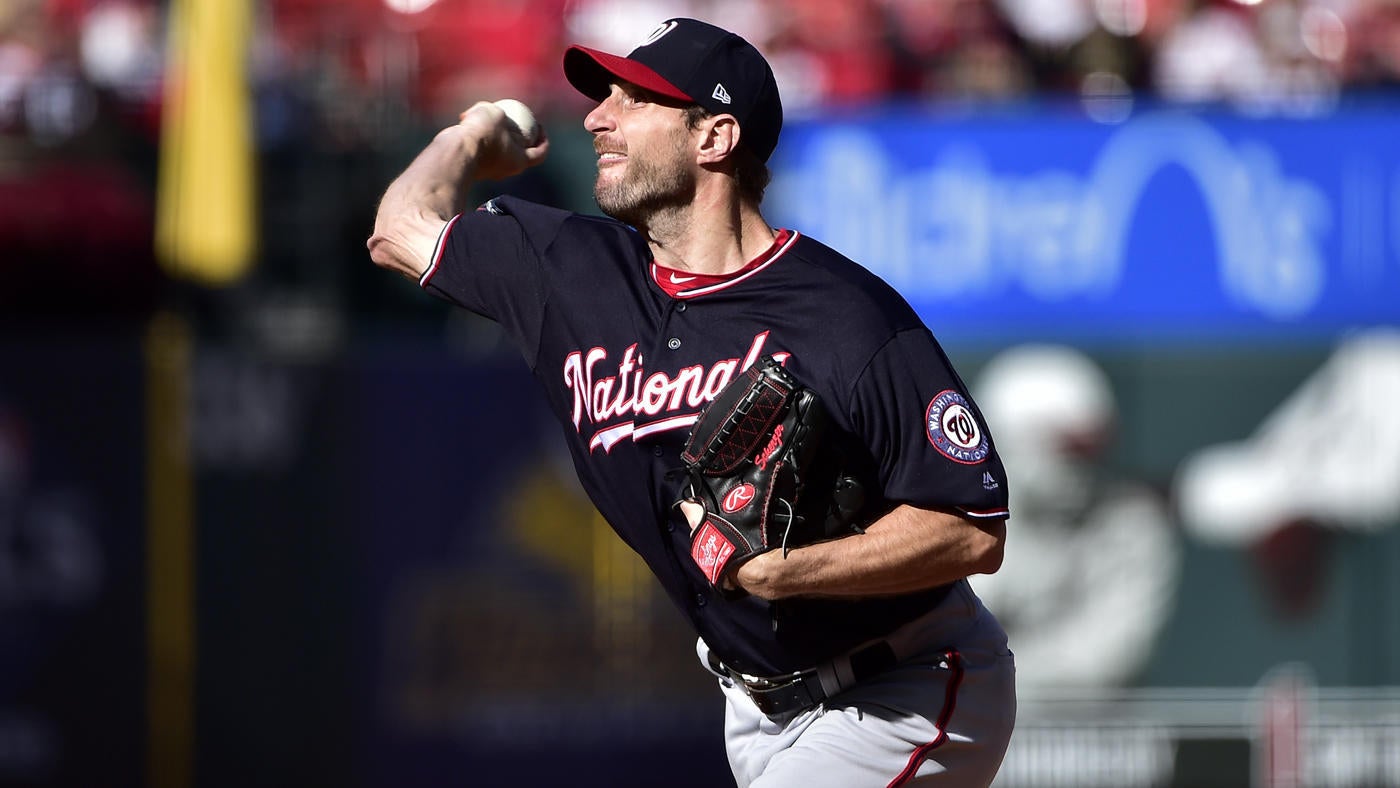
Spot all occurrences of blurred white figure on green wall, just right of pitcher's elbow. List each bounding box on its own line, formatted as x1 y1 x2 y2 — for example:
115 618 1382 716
973 344 1180 691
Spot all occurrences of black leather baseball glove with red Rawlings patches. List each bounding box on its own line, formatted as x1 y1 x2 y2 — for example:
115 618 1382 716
676 356 862 588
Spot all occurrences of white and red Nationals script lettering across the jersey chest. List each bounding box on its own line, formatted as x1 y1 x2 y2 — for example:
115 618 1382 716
564 332 790 452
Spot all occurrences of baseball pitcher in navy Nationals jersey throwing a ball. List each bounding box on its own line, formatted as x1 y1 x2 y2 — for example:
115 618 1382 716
368 18 1015 788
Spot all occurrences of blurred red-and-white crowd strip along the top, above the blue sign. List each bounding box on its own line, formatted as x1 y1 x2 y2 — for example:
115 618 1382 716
0 0 1400 150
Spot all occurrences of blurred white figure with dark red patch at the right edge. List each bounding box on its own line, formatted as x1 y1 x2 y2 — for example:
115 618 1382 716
1176 328 1400 619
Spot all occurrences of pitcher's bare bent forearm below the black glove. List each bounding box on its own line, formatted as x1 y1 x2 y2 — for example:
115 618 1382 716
734 504 1007 599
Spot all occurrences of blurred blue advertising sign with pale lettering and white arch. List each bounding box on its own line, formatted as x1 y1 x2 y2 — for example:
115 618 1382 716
767 104 1400 342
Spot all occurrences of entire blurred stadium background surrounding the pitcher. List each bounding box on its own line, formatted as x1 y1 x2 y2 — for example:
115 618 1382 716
0 0 1400 788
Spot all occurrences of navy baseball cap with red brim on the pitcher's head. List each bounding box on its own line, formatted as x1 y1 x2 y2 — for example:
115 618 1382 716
564 18 783 161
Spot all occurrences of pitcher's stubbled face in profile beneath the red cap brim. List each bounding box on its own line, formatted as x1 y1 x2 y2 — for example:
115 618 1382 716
584 84 696 227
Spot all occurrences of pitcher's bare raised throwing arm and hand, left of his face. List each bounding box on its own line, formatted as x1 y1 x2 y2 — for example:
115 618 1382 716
367 101 549 280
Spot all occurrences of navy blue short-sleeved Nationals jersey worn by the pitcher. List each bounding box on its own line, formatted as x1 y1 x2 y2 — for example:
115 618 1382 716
421 197 1008 675
